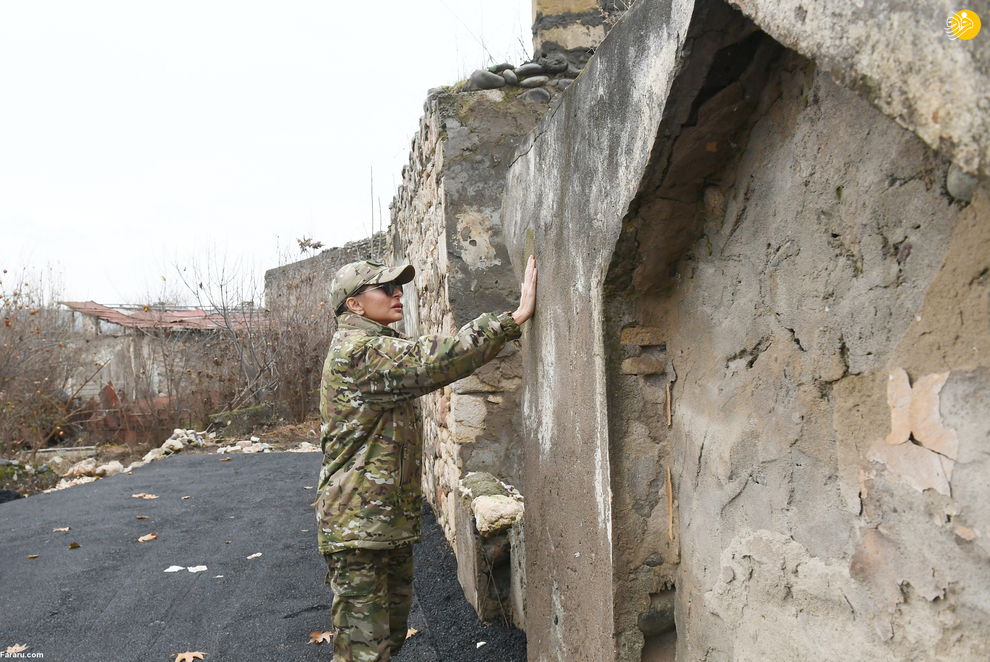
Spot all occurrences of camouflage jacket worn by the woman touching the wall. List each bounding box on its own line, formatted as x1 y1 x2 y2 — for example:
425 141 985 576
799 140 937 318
316 313 520 554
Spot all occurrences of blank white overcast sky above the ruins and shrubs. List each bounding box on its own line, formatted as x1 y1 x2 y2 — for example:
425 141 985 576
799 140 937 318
0 0 532 303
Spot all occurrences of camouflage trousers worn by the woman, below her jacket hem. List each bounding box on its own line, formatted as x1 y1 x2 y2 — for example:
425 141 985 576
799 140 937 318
323 545 413 662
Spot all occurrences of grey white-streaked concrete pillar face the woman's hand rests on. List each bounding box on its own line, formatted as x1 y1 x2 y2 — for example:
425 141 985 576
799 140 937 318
502 0 691 661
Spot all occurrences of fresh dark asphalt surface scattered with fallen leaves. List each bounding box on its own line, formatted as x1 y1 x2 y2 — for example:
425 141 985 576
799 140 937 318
0 453 526 662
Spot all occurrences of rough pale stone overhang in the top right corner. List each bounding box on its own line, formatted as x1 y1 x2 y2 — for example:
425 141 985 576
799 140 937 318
732 0 990 177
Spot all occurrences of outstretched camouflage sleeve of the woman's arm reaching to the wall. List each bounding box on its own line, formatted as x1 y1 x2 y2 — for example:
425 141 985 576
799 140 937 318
352 313 522 408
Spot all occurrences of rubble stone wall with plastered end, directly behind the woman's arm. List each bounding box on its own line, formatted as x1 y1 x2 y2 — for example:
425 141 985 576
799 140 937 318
391 87 547 623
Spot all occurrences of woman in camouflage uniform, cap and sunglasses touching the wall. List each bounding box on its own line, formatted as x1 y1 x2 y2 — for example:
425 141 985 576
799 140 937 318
316 257 537 662
